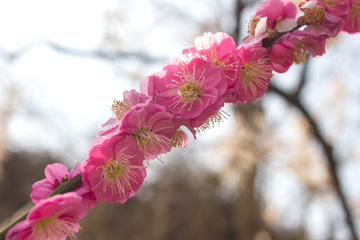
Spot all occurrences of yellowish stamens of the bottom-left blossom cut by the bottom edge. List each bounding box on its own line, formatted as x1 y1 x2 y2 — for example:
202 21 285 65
31 216 77 240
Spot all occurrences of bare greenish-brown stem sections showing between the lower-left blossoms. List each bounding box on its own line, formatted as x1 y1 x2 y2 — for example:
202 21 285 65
0 174 82 240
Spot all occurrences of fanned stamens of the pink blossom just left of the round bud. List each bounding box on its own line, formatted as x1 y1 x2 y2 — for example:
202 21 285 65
240 57 273 99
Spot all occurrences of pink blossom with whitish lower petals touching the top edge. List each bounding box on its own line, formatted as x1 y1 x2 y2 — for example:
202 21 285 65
255 0 297 32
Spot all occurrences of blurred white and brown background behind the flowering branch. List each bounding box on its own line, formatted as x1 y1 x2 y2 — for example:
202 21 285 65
0 0 360 240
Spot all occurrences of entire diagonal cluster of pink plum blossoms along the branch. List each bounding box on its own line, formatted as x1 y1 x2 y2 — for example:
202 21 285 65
6 0 360 239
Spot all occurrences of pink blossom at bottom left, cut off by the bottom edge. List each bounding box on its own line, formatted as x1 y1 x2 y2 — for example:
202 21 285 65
5 192 86 240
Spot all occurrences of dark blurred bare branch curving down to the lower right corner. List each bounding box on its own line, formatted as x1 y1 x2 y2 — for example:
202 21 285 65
268 84 359 240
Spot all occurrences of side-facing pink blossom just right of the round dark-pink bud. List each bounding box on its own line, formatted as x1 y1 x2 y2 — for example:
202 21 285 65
278 30 326 64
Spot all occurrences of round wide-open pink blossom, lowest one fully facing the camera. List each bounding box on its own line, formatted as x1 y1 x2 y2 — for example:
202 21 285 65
80 135 146 203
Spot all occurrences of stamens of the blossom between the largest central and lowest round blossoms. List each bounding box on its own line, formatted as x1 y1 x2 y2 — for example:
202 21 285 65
132 128 171 162
